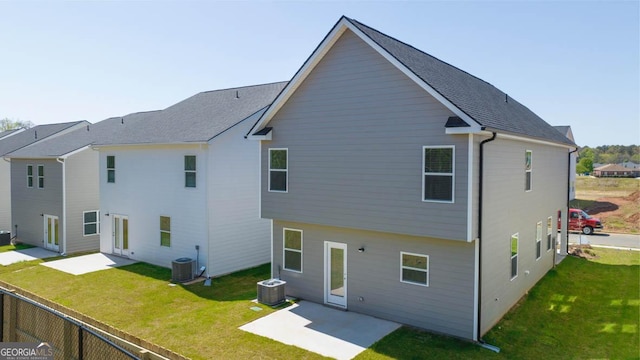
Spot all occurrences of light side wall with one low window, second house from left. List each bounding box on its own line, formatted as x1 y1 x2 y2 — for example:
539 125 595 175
65 149 104 254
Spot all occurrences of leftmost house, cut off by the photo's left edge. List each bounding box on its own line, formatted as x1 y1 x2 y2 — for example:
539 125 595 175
0 121 87 236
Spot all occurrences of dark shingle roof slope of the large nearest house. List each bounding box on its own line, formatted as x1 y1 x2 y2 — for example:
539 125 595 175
346 18 574 145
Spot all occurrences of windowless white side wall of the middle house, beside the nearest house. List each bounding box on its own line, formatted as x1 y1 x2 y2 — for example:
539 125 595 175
208 117 271 275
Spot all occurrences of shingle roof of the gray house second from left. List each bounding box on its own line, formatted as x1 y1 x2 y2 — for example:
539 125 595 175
7 110 159 158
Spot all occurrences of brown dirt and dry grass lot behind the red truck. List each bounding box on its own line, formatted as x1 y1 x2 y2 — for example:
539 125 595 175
571 177 640 234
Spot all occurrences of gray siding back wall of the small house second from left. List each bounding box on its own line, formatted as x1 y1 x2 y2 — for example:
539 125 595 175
11 159 63 246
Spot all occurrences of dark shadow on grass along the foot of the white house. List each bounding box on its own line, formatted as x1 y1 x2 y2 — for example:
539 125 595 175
117 262 271 301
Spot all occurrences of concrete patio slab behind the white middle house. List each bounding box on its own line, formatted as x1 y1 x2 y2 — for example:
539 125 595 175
40 253 137 275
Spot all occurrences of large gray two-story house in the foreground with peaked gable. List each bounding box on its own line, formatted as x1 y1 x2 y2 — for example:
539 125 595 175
247 17 576 340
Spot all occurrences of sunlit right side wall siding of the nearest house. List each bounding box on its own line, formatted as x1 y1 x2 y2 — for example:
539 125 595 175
481 137 568 333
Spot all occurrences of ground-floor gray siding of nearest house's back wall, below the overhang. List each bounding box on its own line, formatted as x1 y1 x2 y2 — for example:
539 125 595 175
272 221 474 339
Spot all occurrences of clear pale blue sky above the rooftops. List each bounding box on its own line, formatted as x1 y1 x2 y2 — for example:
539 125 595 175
0 0 640 147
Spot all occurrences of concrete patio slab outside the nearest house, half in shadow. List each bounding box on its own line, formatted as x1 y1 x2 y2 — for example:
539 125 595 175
240 301 400 359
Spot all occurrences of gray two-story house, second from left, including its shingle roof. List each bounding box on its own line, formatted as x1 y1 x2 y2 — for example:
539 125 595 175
5 114 151 254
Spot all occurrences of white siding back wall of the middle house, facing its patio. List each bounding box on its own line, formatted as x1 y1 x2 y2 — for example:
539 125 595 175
100 145 208 267
